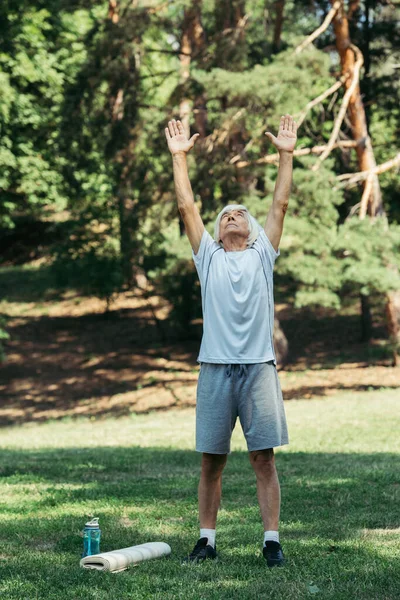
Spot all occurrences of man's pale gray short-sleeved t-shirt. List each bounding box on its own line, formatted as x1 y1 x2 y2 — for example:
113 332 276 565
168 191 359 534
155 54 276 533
192 229 280 364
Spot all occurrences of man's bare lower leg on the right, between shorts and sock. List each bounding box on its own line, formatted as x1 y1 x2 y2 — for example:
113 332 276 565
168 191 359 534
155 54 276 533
250 448 281 531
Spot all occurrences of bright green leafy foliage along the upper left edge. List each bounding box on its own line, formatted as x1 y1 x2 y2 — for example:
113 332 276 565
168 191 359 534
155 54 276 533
0 3 75 227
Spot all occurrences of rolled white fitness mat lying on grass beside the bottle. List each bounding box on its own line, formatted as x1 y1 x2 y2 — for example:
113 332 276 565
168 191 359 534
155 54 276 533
79 542 171 573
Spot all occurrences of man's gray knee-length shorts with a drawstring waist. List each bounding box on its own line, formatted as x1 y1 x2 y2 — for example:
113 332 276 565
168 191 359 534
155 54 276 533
196 360 289 454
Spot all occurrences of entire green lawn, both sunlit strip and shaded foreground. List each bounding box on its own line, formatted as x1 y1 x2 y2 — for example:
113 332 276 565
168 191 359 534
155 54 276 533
0 389 400 600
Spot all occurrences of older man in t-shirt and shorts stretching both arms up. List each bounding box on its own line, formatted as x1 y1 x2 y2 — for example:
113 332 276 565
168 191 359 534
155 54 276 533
165 115 297 567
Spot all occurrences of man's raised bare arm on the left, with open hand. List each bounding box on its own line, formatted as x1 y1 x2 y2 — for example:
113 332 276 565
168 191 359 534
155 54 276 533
165 119 204 254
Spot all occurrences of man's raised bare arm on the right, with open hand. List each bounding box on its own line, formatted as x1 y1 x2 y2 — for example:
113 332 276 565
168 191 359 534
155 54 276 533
264 115 297 250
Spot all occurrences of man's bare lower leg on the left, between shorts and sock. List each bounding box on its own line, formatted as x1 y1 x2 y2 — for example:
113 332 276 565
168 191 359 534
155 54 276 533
199 452 227 529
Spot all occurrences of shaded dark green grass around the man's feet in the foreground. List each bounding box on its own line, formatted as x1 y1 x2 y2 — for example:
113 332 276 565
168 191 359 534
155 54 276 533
0 447 400 600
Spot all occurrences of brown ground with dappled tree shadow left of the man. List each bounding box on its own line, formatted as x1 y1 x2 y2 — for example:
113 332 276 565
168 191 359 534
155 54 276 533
0 307 198 426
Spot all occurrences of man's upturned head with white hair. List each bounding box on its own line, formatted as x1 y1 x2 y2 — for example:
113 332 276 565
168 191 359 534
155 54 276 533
214 204 261 248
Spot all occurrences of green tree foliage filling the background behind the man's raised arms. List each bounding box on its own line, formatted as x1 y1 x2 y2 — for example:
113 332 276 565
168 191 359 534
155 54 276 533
0 0 400 346
